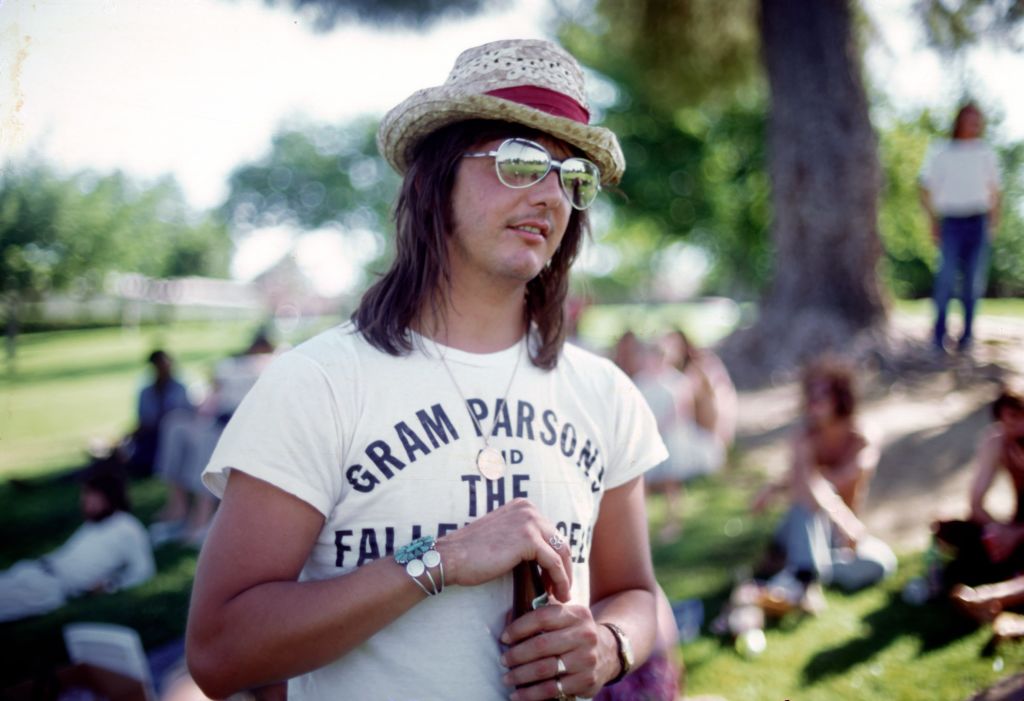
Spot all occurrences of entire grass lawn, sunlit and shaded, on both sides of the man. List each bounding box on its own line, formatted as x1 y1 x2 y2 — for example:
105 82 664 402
0 315 1024 701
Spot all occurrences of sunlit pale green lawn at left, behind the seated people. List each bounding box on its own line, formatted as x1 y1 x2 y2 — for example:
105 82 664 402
0 321 331 478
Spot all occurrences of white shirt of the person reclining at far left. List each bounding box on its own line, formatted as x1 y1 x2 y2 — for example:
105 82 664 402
46 511 157 597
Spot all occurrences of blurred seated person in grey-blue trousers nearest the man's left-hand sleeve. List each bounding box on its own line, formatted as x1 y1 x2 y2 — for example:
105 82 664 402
151 332 274 545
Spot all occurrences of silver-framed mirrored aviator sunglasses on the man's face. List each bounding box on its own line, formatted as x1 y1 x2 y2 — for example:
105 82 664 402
463 138 601 210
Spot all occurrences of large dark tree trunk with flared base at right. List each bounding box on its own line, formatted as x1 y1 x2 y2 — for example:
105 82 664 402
724 0 886 385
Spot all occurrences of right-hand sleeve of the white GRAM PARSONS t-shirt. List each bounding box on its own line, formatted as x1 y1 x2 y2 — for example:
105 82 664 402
604 367 669 489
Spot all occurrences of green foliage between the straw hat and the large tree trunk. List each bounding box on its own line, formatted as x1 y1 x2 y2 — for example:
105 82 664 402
560 0 771 297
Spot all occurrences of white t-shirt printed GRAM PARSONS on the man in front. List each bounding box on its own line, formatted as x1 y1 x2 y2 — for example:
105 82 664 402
204 323 667 701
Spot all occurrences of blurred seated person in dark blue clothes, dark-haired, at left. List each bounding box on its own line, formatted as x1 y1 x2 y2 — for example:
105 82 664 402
128 349 193 477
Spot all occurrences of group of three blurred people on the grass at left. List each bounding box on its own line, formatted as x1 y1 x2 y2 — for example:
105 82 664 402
0 330 274 622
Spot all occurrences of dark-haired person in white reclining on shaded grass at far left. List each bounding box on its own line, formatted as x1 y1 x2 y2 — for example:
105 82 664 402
0 458 156 621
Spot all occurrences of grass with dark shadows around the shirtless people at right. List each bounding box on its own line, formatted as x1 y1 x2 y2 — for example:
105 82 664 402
650 468 1024 701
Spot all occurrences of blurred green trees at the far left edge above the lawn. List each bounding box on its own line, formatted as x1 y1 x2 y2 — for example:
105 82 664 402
0 162 230 353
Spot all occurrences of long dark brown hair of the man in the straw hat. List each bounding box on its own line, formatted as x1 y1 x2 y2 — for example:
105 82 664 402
352 120 589 369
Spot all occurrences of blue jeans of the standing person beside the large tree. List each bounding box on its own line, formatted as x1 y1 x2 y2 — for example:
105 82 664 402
933 214 988 348
